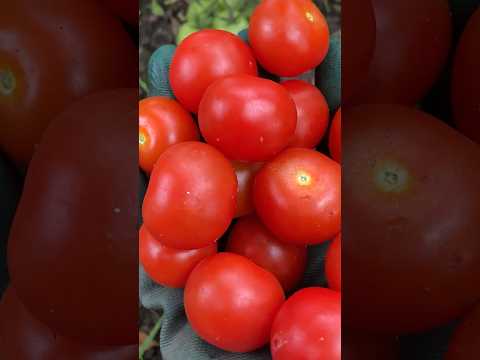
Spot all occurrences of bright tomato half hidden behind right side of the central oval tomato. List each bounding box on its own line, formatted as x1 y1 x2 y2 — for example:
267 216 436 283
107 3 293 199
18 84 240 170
282 80 330 148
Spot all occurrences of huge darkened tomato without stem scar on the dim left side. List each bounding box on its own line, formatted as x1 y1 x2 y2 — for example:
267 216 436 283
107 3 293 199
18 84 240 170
8 89 138 345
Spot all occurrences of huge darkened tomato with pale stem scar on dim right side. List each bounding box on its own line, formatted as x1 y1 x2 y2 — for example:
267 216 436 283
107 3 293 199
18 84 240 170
342 105 480 333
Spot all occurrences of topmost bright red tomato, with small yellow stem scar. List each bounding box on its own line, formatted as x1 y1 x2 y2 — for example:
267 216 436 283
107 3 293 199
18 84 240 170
248 0 329 77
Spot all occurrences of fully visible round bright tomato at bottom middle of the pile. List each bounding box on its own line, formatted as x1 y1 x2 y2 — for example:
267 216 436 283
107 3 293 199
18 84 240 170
185 253 285 352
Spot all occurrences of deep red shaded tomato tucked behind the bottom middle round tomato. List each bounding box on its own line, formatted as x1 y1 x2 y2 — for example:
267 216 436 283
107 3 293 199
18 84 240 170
227 215 307 292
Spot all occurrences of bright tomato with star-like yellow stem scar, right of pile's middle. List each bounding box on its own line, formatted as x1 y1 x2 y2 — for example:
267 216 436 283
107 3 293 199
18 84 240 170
253 148 341 245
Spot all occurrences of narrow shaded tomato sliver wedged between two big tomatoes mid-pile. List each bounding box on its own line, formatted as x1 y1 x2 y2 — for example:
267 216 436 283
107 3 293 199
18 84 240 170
232 161 263 217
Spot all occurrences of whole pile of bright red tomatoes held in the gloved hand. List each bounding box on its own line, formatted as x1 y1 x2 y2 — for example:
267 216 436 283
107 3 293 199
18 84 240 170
139 0 341 360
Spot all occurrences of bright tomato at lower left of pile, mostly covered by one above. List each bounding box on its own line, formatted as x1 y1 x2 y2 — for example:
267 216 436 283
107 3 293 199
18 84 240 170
139 225 217 288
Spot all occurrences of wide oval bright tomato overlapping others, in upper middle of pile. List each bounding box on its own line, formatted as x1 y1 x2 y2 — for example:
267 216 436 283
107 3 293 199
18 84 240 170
198 75 297 161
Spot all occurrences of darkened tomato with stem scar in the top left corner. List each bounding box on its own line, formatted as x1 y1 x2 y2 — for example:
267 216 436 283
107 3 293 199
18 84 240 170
0 0 138 166
